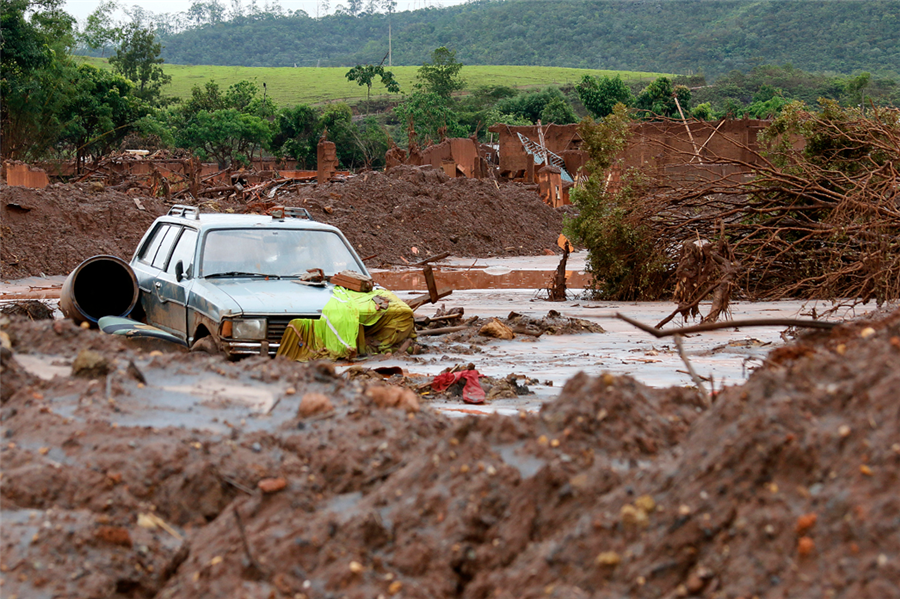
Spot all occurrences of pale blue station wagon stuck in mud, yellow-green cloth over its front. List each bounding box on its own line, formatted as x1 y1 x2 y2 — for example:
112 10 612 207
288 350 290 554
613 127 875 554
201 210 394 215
63 205 412 359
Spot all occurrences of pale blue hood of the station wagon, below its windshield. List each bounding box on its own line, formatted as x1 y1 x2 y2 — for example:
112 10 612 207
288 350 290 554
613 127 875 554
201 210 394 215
194 279 334 316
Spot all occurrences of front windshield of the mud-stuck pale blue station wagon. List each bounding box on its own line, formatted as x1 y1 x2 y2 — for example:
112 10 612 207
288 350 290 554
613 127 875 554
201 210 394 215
201 228 363 277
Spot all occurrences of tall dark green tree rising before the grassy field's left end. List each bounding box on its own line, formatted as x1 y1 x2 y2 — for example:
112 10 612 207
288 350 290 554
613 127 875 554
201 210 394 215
109 23 172 104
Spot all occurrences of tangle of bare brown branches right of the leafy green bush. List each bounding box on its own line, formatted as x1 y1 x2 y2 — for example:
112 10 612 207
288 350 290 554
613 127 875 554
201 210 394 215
627 104 900 307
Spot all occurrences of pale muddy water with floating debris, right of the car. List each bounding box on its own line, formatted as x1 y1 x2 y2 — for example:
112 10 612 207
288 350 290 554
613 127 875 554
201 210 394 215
379 289 864 415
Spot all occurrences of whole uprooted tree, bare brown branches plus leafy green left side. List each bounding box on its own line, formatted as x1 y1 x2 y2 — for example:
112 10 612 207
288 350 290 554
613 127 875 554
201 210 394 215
570 101 900 314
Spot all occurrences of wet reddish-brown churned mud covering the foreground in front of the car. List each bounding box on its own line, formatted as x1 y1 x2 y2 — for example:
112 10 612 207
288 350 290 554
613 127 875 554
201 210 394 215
0 312 900 599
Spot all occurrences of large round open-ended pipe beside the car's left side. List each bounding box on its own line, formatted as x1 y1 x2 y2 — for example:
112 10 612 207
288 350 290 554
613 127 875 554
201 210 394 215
59 256 140 323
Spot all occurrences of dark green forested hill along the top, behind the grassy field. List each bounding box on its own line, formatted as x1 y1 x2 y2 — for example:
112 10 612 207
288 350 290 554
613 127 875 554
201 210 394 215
162 0 900 76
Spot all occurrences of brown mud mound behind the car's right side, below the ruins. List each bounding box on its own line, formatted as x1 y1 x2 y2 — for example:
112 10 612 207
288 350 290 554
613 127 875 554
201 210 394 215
279 166 563 264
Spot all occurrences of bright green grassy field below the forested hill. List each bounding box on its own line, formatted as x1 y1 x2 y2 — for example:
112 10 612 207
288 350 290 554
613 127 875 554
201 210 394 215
79 57 663 106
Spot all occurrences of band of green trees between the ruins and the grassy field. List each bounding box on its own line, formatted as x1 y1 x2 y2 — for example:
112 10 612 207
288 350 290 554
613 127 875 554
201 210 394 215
0 0 900 169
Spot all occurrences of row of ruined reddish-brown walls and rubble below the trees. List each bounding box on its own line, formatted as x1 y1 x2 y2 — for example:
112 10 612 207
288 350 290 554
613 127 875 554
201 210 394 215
4 119 769 212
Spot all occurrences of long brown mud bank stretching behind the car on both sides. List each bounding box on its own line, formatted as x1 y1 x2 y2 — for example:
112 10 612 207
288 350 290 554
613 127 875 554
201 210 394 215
0 166 563 279
